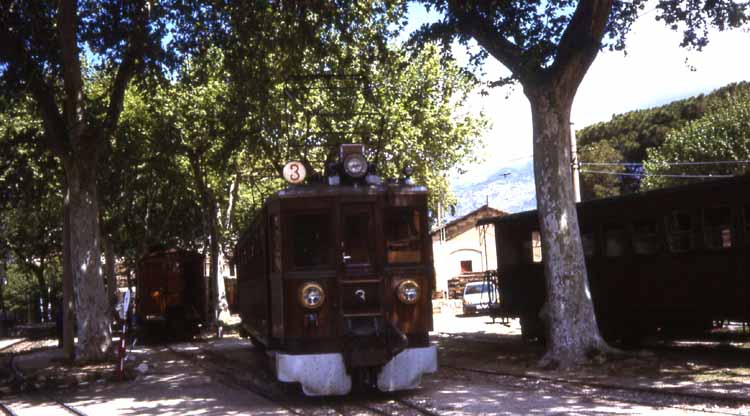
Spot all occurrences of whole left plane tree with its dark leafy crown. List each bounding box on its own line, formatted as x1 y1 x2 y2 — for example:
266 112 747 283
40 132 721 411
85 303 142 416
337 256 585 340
0 0 173 361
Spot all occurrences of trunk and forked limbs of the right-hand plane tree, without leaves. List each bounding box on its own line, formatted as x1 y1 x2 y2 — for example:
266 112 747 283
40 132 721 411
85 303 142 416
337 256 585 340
449 0 612 367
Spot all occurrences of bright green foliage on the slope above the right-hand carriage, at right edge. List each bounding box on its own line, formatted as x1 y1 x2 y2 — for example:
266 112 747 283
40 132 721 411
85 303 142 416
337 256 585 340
643 84 750 189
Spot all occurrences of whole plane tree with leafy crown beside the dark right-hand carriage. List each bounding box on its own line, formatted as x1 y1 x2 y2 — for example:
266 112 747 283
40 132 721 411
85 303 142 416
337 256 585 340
415 0 748 367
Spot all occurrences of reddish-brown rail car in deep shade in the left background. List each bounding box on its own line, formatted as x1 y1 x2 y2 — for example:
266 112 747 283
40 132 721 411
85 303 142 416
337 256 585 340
135 249 208 337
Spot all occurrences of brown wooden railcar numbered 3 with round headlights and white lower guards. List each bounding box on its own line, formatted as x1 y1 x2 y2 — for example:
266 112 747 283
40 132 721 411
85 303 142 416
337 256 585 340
234 145 437 395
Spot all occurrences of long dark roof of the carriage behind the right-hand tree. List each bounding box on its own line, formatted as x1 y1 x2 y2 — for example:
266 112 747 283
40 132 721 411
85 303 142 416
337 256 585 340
477 175 750 229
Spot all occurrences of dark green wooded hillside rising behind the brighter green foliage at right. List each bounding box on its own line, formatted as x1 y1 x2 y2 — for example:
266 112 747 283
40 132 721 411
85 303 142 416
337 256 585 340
576 82 750 199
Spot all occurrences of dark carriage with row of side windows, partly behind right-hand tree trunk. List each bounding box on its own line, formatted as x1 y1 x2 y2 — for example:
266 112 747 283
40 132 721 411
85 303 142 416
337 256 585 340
479 176 750 342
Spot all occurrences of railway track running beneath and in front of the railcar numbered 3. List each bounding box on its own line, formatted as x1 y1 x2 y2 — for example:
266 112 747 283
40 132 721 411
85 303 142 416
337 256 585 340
166 344 439 416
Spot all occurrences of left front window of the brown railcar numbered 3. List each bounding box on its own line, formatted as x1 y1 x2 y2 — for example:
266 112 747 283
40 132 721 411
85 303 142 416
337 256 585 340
290 214 331 267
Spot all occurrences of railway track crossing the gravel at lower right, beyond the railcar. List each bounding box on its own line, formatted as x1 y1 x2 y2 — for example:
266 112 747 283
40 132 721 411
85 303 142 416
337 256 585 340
441 363 750 415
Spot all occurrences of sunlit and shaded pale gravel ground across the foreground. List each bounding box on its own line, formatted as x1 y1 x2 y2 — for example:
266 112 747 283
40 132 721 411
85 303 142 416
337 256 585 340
0 313 750 416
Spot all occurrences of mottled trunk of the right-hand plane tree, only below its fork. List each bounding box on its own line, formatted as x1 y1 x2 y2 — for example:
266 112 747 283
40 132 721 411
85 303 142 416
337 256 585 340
524 85 610 367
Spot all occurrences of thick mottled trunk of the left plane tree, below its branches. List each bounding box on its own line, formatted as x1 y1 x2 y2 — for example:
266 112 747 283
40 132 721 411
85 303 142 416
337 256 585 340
65 152 112 361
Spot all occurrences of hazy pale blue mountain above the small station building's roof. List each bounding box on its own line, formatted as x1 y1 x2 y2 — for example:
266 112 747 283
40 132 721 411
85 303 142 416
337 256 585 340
452 159 536 217
